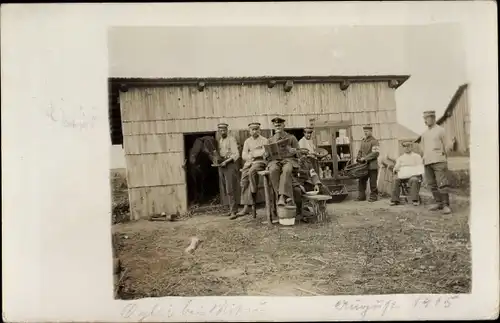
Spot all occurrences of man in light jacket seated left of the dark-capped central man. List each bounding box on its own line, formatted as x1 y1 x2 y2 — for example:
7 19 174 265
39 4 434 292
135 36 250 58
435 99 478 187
234 122 268 219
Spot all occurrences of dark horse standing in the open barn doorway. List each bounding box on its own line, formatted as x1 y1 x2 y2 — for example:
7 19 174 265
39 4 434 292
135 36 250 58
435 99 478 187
184 136 221 203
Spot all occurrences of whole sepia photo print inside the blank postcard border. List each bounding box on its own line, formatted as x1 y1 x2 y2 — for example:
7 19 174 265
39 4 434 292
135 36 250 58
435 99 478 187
108 24 471 299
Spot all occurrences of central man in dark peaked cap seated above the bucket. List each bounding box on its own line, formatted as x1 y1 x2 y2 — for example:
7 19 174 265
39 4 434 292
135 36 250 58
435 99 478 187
268 117 299 206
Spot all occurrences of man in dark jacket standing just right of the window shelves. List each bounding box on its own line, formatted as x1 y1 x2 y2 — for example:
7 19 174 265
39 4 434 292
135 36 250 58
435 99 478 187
356 126 379 202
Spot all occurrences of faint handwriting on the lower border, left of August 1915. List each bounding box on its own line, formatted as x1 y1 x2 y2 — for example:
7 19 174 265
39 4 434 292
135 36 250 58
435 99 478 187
121 300 267 322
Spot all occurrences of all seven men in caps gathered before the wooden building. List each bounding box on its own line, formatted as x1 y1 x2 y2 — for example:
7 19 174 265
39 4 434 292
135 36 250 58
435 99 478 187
213 111 451 219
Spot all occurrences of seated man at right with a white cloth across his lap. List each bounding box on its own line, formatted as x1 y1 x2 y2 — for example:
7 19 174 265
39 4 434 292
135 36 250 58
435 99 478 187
391 141 424 206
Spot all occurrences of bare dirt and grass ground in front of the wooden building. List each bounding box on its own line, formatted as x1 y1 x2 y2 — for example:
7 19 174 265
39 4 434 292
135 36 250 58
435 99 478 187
113 195 471 299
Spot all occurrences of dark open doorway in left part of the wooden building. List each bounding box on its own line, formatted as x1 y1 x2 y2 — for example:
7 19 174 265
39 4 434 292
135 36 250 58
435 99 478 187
184 132 220 207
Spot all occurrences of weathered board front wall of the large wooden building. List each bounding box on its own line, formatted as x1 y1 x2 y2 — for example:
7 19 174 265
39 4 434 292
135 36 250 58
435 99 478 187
120 81 398 218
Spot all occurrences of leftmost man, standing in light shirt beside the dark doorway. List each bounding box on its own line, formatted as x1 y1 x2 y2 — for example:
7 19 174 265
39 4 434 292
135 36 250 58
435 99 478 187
217 123 240 216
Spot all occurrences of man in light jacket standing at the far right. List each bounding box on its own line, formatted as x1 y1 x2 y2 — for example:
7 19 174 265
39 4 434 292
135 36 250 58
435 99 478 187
420 111 451 214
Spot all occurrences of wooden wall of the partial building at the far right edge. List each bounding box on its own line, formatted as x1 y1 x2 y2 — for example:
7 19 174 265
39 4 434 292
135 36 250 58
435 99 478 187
441 89 470 155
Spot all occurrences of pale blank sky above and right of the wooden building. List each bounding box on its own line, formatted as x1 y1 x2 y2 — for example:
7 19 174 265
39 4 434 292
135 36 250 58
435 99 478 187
108 24 467 168
